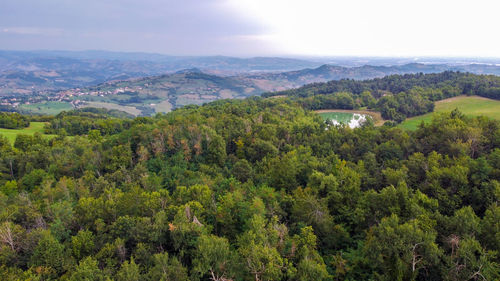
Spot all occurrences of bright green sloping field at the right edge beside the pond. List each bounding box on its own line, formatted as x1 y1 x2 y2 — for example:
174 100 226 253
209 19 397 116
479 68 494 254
399 96 500 130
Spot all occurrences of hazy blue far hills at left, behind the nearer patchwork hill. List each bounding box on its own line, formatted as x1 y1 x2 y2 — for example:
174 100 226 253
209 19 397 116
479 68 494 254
0 51 321 96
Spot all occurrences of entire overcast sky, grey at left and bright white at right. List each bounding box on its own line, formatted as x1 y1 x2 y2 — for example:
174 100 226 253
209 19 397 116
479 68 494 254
0 0 500 57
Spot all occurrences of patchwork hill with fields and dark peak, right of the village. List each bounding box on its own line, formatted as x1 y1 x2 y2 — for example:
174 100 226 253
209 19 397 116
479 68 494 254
70 69 289 114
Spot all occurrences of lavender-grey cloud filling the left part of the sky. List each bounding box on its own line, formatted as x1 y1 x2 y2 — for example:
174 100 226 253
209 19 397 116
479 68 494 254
0 0 270 55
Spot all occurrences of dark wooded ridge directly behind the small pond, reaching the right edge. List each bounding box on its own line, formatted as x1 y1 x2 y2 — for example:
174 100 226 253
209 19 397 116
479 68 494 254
263 71 500 122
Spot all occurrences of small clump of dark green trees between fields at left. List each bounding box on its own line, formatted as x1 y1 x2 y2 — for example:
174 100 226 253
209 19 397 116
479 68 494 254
45 108 132 136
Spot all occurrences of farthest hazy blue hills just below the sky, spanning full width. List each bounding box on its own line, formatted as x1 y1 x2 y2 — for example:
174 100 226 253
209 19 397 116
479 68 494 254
0 51 500 96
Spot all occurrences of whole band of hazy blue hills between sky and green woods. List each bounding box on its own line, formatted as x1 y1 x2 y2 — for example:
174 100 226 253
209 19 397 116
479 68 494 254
0 51 500 114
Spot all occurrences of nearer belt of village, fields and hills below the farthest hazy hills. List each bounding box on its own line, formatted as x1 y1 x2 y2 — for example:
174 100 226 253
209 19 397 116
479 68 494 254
6 60 500 116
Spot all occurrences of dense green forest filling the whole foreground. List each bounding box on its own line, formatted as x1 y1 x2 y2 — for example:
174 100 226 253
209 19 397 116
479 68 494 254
0 98 500 281
